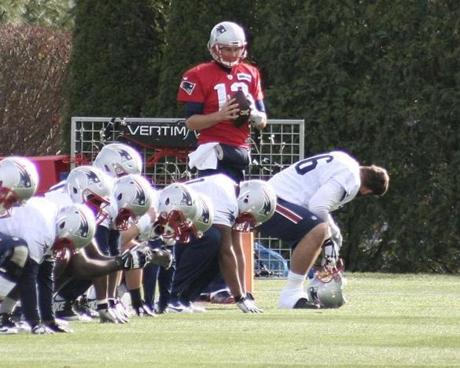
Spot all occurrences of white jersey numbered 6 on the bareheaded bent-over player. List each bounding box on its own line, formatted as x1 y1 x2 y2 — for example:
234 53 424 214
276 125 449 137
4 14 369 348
268 151 361 220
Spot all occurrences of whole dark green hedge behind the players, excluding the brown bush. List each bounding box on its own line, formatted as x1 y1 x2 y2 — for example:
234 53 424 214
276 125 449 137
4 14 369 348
65 0 460 272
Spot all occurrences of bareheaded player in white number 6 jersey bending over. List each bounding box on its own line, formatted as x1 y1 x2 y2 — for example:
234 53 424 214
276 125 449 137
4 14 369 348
259 151 389 309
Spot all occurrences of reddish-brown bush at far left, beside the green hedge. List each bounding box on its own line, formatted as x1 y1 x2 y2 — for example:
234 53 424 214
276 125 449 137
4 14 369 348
0 25 70 156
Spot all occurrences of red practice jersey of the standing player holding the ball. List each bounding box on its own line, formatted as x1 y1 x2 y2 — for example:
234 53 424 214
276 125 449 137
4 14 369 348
177 61 263 147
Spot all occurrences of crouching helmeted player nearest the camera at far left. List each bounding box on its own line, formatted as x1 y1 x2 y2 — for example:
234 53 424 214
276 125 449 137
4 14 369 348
0 197 158 334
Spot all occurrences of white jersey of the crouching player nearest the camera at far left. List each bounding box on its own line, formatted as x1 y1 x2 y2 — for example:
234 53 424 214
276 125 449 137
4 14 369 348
0 197 58 263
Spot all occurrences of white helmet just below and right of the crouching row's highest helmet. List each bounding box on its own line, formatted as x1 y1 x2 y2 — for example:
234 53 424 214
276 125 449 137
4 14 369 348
113 174 154 230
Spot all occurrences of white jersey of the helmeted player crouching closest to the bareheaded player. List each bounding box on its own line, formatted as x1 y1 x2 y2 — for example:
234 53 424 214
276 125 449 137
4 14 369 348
185 174 238 227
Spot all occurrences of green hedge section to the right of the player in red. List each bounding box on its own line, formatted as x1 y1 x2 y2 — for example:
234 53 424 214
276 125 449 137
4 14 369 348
254 1 460 272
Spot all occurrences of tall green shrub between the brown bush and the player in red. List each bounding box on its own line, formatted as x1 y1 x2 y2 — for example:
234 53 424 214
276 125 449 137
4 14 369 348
65 0 166 150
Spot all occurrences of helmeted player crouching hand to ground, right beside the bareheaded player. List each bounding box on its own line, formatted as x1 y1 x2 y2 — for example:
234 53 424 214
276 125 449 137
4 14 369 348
168 174 276 313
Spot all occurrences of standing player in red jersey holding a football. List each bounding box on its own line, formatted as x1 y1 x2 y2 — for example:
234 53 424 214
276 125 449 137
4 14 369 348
177 22 267 183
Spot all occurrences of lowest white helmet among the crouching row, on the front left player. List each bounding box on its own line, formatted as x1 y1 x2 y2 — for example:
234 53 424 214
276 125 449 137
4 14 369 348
53 203 96 251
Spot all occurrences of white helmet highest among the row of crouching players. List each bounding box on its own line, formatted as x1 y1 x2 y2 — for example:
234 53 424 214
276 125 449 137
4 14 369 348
93 143 142 178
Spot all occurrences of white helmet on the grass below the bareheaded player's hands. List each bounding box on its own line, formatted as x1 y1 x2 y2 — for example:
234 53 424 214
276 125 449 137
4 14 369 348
307 269 346 308
